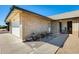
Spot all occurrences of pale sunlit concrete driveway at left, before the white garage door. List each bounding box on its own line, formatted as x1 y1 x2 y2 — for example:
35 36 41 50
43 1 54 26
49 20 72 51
0 33 32 54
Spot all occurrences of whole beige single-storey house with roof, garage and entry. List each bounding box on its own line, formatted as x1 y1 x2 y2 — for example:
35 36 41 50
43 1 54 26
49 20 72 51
6 6 79 39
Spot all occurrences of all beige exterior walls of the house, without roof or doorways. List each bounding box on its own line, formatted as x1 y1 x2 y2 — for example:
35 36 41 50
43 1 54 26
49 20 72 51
6 10 79 39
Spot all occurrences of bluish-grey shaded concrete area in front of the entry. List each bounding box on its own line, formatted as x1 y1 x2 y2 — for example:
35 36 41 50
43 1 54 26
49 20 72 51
41 34 69 47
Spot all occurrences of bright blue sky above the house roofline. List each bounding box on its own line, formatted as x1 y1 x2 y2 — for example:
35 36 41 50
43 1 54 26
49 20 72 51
0 5 79 25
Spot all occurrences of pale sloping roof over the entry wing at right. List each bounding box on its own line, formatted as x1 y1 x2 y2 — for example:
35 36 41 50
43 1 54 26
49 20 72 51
48 10 79 20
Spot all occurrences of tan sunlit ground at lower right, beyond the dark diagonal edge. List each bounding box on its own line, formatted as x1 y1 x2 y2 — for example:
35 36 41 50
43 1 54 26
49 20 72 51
57 35 79 54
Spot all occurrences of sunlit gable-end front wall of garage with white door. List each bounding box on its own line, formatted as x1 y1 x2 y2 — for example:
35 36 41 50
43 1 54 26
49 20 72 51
10 12 22 38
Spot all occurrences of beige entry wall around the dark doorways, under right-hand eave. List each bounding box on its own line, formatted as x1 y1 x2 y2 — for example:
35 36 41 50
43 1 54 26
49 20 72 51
60 18 79 36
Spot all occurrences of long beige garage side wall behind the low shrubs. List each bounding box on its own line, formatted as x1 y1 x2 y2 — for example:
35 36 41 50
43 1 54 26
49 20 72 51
21 12 51 39
